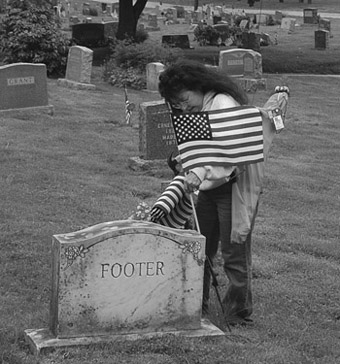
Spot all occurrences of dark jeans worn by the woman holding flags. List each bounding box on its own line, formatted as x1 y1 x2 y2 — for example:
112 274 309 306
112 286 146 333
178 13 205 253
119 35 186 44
196 182 253 319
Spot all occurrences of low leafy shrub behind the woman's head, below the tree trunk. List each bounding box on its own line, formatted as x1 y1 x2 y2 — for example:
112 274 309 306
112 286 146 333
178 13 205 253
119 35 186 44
103 41 179 90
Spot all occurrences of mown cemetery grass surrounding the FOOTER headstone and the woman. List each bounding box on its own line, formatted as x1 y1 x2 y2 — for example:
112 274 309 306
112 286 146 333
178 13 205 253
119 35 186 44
0 70 340 364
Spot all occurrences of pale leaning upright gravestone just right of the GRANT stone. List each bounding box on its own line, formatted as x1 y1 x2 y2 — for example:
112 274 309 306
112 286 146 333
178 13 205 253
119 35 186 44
58 46 95 89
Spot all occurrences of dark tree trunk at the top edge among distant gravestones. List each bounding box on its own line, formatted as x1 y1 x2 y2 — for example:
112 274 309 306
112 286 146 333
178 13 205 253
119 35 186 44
116 0 148 40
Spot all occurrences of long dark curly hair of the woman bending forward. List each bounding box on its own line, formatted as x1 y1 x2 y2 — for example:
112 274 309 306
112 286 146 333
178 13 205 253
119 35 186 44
158 60 248 105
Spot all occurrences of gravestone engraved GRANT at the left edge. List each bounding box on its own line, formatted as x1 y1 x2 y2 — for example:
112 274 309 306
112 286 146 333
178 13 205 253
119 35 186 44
0 63 53 114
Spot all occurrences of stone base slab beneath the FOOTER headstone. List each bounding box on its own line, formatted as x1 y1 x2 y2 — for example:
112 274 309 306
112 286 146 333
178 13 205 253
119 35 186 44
24 319 225 355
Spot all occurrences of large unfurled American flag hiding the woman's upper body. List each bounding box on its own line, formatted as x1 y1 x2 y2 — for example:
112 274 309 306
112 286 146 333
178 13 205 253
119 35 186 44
171 106 263 172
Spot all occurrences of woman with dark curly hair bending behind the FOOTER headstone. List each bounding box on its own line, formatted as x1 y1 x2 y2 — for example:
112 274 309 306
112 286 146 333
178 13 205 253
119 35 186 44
159 61 253 325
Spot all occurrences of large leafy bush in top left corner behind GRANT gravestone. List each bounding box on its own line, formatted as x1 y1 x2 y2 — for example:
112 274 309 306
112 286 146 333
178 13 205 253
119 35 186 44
0 2 70 76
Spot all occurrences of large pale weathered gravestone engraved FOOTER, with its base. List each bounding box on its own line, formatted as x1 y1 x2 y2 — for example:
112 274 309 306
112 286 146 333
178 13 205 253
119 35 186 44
25 220 224 354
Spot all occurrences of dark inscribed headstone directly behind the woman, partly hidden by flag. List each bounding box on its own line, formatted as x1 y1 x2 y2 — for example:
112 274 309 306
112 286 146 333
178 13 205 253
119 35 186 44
139 101 177 160
